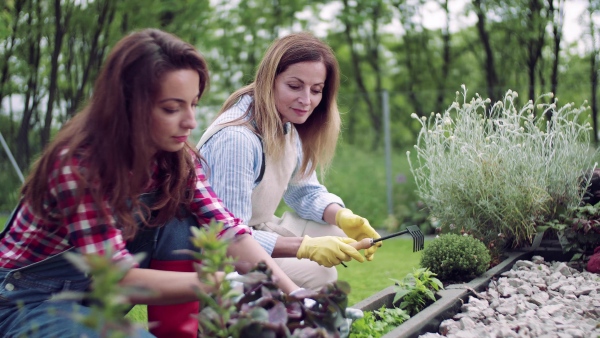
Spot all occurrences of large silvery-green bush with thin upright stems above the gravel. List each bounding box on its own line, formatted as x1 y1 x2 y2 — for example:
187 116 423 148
409 85 594 246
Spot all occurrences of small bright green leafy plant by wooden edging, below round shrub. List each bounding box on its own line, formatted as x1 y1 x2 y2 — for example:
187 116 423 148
392 268 444 316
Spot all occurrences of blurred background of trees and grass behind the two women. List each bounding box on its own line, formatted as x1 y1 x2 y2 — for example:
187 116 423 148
0 0 600 230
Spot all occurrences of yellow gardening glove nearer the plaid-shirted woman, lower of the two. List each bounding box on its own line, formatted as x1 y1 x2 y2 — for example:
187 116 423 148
296 236 365 268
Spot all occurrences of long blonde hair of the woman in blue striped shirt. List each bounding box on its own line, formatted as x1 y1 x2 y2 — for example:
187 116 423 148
219 32 341 177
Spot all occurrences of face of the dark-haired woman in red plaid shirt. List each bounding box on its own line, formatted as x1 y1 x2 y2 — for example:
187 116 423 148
150 69 200 152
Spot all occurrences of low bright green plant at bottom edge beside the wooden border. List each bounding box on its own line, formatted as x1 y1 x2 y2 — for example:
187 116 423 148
349 307 410 338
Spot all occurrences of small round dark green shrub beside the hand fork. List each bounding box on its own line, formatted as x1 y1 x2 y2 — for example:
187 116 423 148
421 234 491 281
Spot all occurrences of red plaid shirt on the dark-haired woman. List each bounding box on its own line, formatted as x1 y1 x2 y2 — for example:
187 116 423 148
0 150 250 269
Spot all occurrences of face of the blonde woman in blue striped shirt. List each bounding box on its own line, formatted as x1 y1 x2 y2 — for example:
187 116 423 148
275 61 327 124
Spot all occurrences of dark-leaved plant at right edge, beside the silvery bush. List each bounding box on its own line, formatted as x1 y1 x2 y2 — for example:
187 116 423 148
547 204 600 260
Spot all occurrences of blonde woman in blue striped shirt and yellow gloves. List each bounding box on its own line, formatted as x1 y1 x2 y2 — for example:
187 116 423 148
197 33 381 290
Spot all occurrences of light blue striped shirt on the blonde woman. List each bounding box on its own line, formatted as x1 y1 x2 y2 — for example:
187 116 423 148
200 96 344 255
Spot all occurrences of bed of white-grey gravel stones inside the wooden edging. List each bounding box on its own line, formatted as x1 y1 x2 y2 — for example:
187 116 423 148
419 256 600 338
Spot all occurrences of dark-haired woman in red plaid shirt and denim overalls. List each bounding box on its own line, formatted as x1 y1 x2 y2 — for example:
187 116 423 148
0 29 298 337
